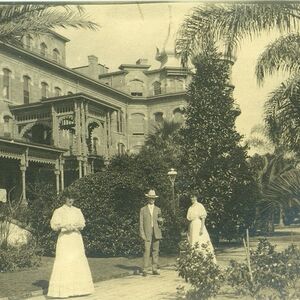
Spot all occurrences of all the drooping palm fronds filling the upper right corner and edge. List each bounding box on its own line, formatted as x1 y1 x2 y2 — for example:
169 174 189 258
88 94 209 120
176 2 300 152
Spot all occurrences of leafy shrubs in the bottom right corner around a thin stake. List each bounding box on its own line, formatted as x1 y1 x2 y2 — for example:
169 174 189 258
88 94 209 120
226 239 300 300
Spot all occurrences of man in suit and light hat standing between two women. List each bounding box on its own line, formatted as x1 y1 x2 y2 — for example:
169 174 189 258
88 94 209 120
140 190 163 276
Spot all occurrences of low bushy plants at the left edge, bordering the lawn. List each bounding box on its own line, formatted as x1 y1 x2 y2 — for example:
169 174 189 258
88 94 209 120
0 241 42 272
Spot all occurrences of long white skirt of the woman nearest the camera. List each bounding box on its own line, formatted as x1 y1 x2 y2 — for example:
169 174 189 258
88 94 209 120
47 232 94 298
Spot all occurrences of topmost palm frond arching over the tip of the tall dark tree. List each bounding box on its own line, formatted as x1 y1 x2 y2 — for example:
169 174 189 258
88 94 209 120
175 2 300 65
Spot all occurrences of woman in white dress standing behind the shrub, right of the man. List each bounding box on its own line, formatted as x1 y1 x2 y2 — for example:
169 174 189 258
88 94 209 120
187 195 217 263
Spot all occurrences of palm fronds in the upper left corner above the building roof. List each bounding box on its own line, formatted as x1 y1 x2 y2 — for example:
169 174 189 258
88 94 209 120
0 4 98 45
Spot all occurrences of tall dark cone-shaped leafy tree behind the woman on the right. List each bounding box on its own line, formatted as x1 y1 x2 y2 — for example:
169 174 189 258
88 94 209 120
179 48 257 239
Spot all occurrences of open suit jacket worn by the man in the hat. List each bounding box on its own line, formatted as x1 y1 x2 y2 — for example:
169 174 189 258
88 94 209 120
140 205 162 241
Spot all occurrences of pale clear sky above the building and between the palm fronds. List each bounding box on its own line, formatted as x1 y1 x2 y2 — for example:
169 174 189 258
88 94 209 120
57 1 282 138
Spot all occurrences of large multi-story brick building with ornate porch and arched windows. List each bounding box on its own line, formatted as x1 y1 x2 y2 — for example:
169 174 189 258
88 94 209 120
0 32 190 199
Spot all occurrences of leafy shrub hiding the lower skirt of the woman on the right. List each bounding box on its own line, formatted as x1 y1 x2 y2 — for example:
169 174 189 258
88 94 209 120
177 241 224 300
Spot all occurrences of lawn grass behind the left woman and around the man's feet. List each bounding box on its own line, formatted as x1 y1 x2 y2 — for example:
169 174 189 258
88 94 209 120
0 257 176 299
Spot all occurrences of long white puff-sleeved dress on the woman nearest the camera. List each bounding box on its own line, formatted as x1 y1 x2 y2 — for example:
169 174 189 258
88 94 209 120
48 205 94 298
